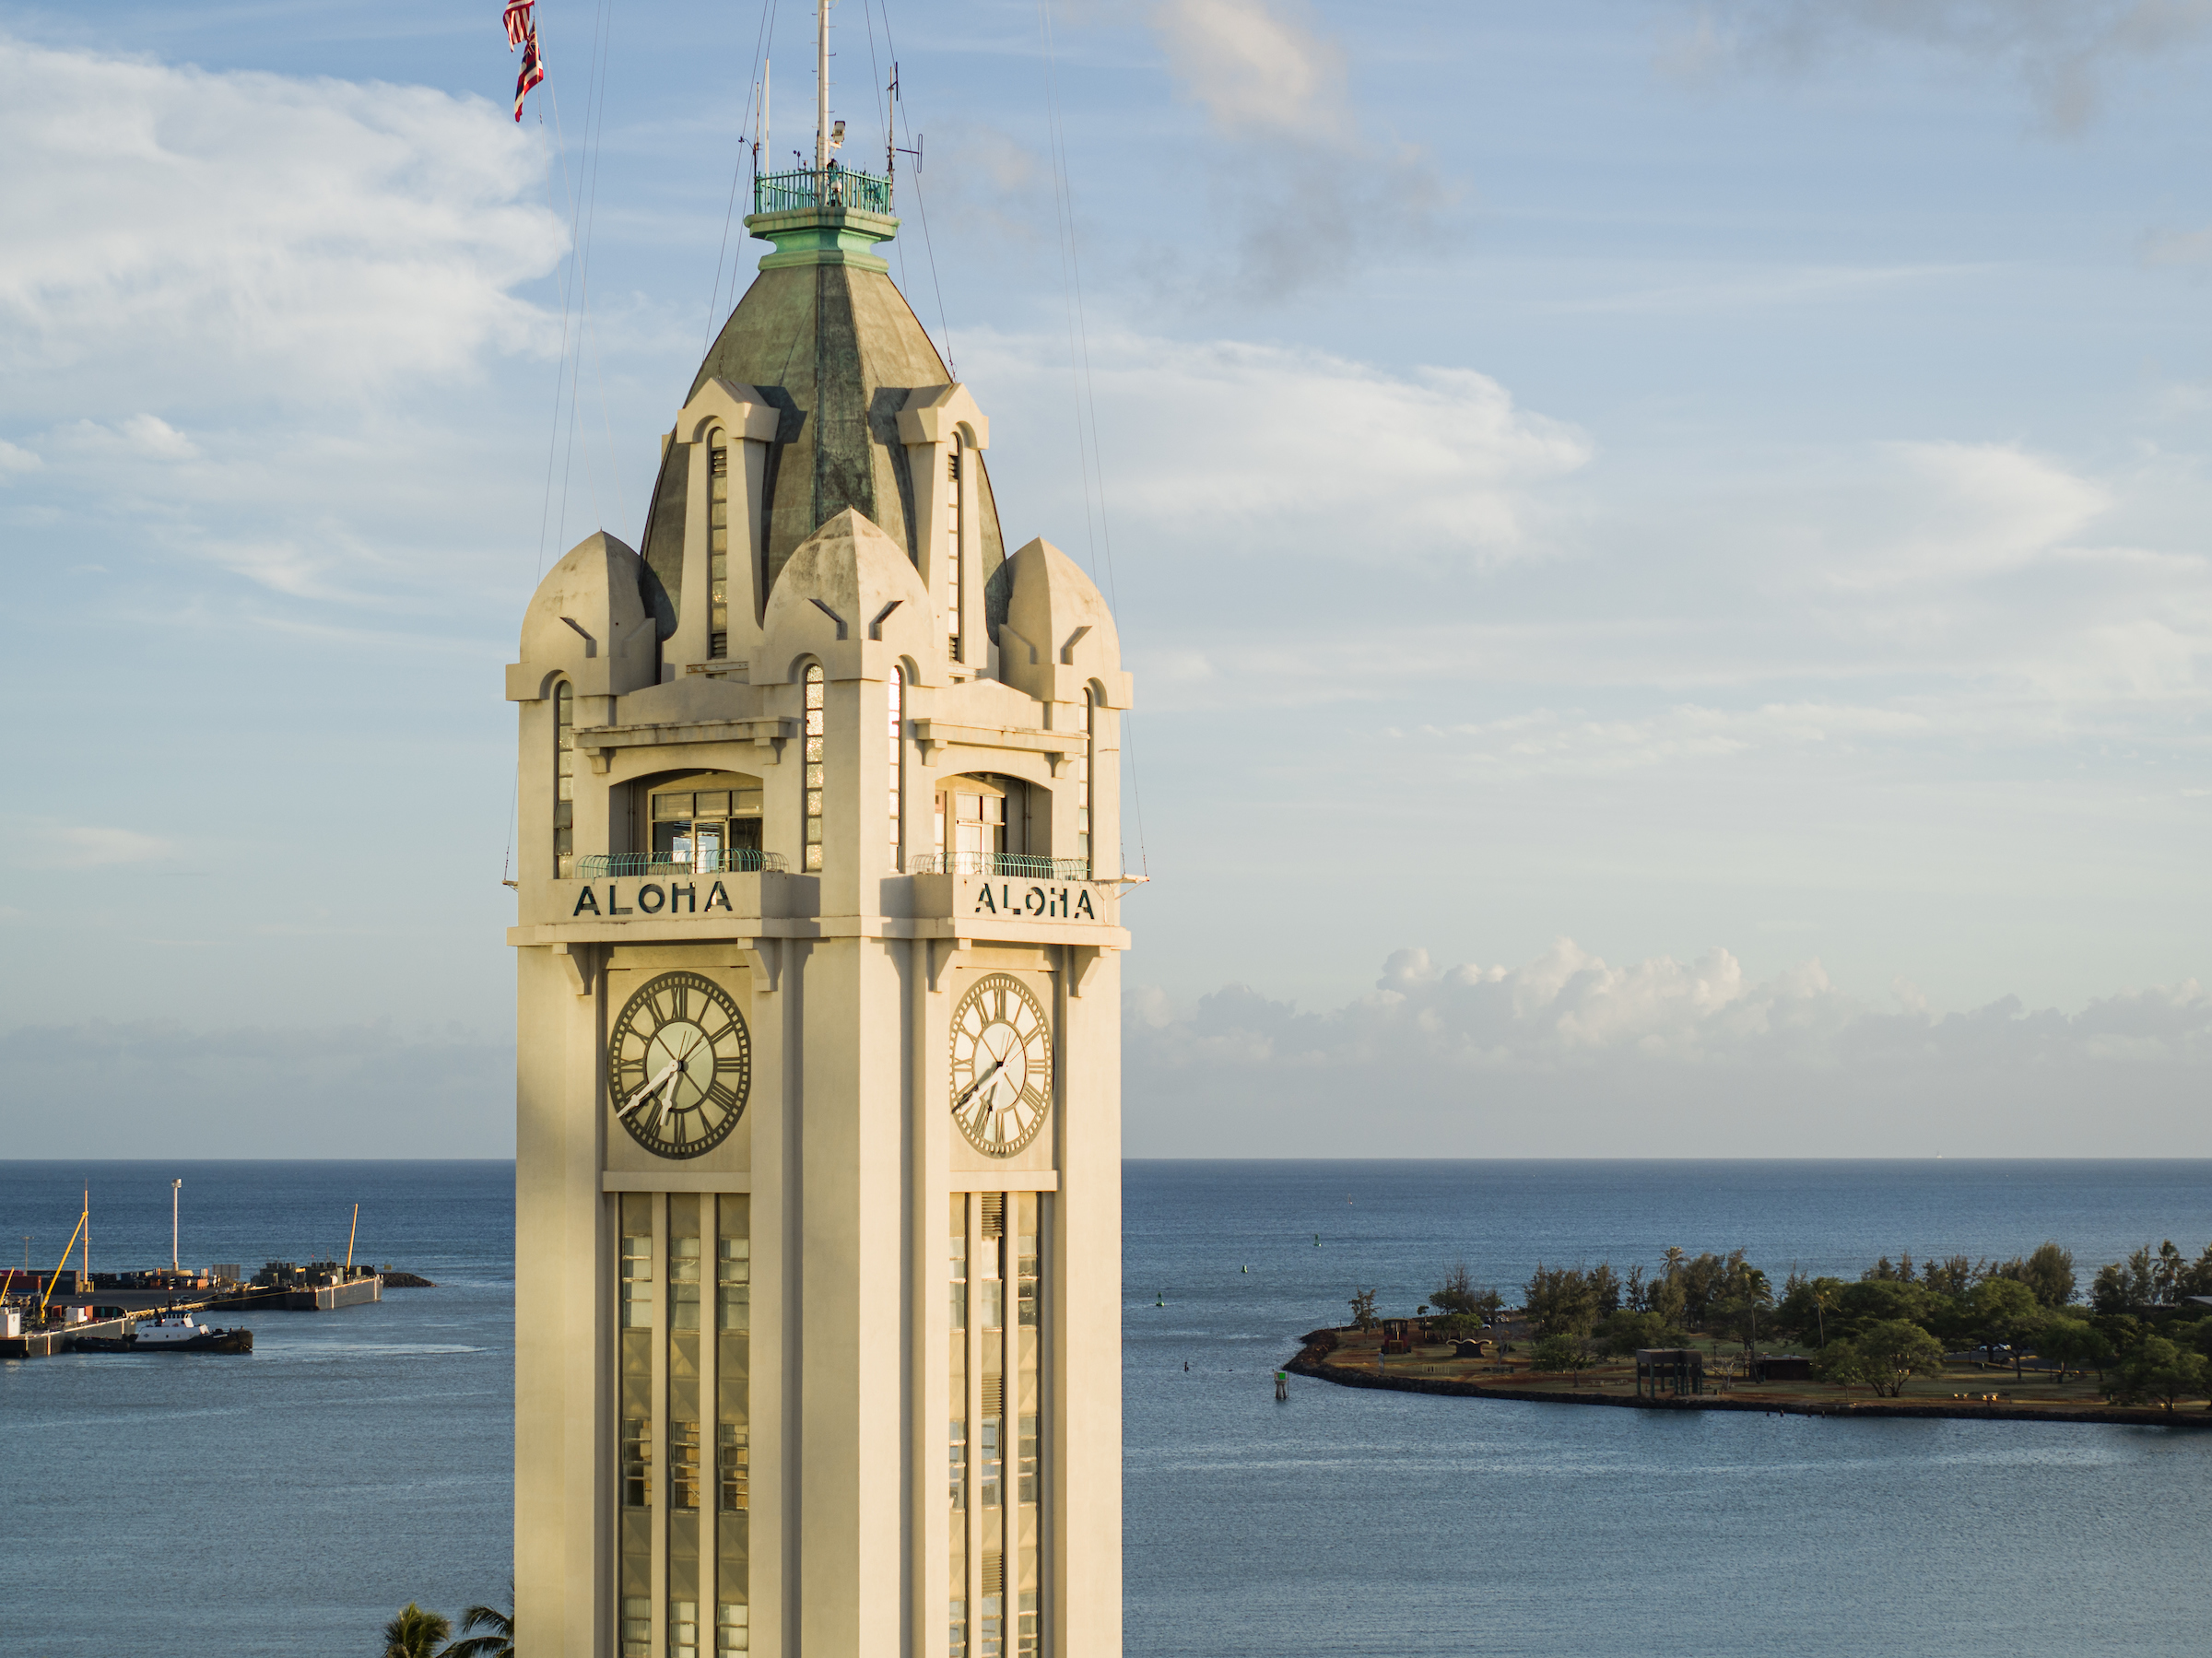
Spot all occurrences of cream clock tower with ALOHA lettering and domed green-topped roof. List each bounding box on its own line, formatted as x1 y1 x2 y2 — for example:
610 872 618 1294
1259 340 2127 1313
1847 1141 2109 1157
507 146 1130 1658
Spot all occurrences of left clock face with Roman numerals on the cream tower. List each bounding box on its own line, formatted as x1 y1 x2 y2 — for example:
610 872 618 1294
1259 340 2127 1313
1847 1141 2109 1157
606 972 752 1157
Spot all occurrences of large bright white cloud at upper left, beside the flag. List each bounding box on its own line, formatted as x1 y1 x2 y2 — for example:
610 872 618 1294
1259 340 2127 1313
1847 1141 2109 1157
0 38 564 403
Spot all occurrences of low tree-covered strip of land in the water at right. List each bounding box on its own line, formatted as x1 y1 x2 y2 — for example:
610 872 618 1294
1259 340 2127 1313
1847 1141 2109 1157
1285 1241 2212 1426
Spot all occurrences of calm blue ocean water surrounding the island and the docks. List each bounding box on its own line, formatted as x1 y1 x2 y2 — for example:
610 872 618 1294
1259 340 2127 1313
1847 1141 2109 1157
0 1160 2212 1658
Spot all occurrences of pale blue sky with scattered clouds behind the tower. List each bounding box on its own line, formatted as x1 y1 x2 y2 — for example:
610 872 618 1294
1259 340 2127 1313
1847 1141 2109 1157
0 0 2212 1157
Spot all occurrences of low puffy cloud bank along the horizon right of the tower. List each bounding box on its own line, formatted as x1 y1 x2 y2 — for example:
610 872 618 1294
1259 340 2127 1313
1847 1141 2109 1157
1124 939 2212 1157
